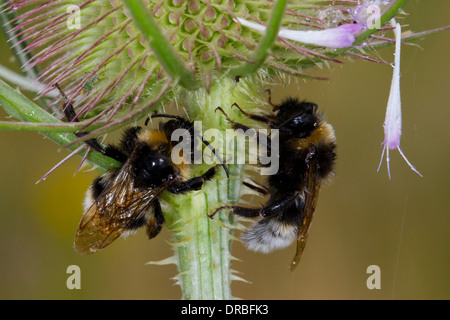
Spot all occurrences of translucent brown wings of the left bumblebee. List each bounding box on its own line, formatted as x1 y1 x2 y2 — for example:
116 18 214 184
75 162 167 254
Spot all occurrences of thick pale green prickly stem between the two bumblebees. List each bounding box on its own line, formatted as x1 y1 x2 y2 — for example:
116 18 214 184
164 77 265 299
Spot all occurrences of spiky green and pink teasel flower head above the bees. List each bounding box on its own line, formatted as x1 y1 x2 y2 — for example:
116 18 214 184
3 0 408 134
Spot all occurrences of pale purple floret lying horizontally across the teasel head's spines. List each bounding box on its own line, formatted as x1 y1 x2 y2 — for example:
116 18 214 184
236 18 363 48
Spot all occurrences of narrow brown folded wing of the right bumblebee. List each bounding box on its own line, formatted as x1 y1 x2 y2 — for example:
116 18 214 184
290 152 320 271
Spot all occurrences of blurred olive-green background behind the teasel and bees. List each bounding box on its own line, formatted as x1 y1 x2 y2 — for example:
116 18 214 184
0 0 450 299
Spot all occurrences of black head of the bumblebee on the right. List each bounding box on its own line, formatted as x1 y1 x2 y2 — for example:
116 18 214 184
277 98 320 138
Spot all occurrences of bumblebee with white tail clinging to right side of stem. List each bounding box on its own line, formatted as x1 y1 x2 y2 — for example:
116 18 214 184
210 97 336 270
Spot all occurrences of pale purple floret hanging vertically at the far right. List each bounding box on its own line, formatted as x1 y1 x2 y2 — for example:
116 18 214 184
377 23 422 179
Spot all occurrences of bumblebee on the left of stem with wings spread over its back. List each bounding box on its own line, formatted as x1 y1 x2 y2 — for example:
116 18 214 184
55 85 228 254
